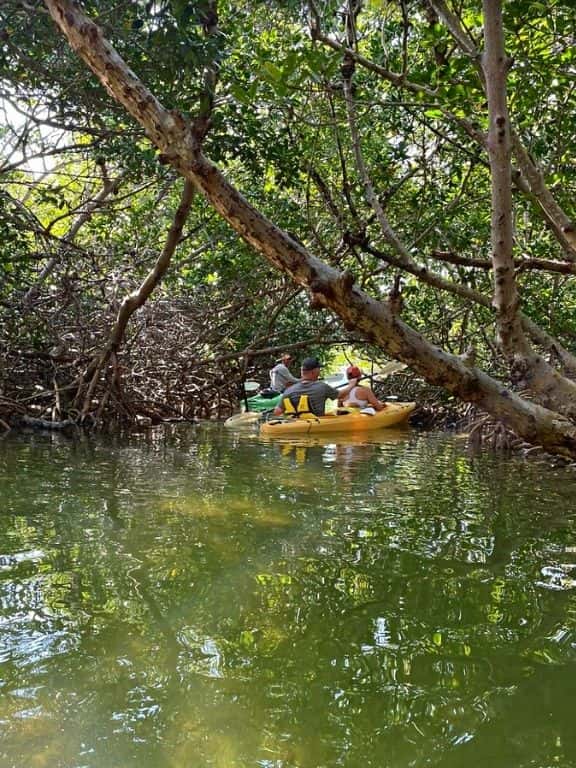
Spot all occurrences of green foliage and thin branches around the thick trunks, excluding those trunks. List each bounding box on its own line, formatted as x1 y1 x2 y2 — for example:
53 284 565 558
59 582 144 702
0 0 576 450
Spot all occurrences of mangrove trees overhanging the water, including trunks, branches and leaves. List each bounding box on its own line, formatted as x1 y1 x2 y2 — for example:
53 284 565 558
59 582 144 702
0 0 576 456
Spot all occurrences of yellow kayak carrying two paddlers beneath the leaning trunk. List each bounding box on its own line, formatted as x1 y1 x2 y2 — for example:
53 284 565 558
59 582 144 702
260 403 416 437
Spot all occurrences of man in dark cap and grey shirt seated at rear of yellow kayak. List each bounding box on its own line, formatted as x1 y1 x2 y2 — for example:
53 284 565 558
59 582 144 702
274 357 357 418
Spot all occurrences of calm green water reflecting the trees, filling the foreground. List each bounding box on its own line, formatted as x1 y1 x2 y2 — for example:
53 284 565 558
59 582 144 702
0 427 576 768
